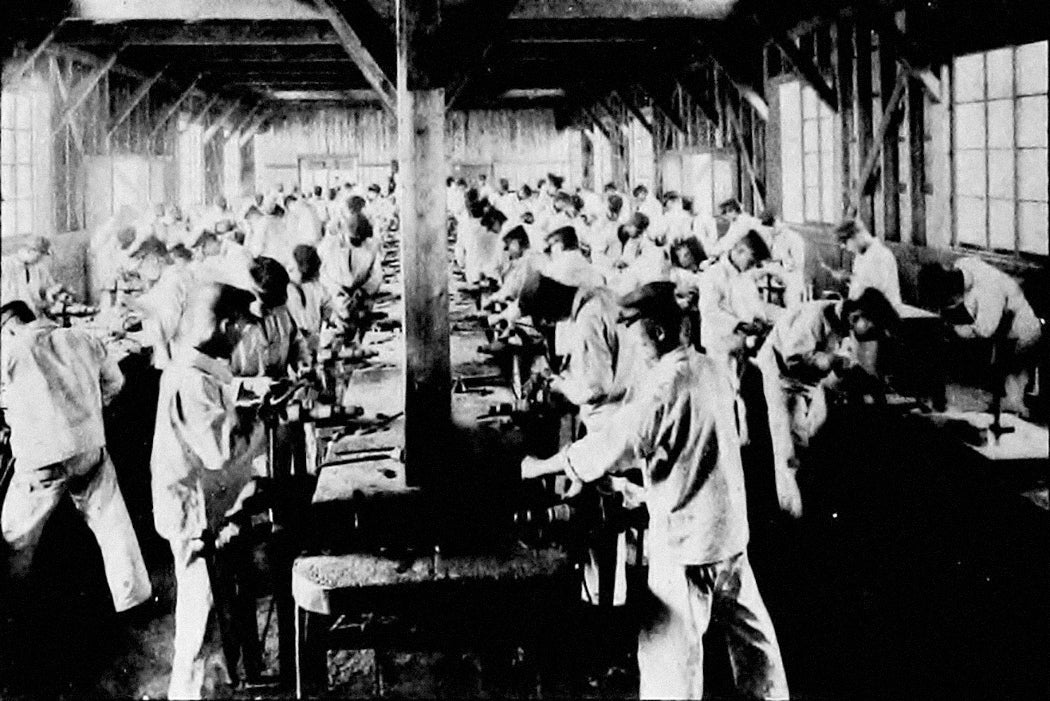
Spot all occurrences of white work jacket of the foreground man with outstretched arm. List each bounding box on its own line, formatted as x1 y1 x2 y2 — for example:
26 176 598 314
560 347 749 565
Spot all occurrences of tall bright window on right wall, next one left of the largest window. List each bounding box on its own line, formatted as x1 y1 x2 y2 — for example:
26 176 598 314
778 80 842 222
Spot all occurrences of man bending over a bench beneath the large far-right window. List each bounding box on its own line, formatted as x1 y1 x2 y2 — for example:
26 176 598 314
919 256 1043 417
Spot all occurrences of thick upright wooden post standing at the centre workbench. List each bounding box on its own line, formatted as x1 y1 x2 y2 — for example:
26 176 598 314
396 0 452 487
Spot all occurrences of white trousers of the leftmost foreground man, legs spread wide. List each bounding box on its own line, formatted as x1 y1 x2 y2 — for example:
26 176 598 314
0 448 152 612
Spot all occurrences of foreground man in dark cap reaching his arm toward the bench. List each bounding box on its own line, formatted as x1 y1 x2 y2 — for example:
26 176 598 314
522 283 789 699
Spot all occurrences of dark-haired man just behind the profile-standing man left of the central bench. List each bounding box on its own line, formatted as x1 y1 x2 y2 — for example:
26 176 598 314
230 257 303 380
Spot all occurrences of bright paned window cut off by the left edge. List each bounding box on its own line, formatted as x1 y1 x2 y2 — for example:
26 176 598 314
0 90 34 238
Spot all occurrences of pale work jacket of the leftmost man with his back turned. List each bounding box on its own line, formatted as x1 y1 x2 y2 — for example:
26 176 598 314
0 319 124 470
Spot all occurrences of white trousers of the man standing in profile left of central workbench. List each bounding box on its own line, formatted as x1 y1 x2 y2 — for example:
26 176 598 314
168 539 230 699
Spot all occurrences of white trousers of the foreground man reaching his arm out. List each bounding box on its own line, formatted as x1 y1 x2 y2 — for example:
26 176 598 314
638 548 789 699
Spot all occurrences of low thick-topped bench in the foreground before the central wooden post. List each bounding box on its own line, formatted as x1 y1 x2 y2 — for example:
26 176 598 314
292 548 576 698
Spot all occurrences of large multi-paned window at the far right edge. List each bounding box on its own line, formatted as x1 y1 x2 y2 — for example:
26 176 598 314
952 41 1050 255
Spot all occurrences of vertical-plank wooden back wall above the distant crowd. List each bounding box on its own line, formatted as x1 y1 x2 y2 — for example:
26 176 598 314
254 107 578 190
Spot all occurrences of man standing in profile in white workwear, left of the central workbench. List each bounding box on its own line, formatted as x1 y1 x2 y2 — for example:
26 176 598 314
150 284 266 699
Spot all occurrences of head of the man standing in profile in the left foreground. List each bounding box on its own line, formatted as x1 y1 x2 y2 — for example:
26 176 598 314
186 283 256 358
